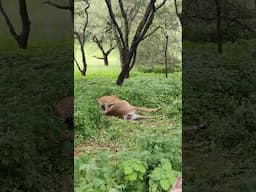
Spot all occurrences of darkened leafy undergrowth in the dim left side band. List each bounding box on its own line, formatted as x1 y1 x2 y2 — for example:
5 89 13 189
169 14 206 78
0 41 73 192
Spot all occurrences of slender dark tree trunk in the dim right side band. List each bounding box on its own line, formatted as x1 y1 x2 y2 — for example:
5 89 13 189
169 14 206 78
215 0 222 54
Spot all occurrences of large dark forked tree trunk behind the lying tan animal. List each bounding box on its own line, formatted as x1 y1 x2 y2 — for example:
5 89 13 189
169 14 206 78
105 0 167 85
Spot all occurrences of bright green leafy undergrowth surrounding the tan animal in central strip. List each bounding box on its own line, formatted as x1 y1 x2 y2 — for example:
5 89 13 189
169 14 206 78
75 73 181 192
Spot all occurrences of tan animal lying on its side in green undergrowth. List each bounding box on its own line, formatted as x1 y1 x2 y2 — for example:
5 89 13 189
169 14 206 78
97 95 161 120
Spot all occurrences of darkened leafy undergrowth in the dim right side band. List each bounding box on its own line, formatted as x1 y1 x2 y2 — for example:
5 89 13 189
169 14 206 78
183 40 256 192
